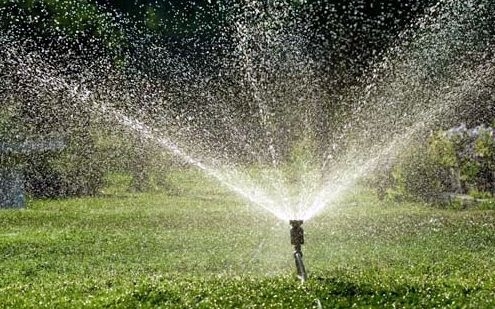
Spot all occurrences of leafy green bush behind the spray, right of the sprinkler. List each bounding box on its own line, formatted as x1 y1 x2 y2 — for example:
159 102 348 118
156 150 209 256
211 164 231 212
372 125 495 203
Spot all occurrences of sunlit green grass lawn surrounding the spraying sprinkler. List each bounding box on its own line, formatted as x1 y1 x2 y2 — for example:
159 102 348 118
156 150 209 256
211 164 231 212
0 172 495 308
